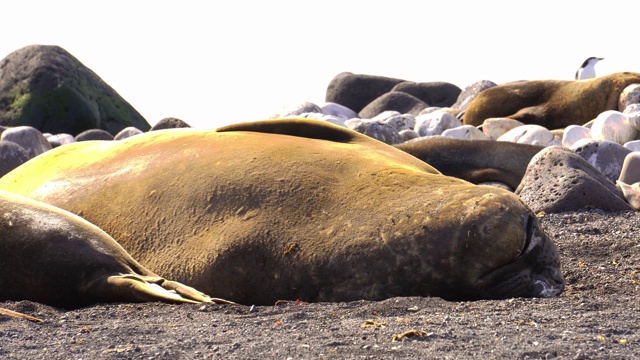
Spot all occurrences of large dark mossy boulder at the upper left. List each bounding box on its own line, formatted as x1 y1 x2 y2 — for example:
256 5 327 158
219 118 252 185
0 45 150 135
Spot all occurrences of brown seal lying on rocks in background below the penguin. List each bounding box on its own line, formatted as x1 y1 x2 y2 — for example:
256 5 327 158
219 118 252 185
463 72 640 130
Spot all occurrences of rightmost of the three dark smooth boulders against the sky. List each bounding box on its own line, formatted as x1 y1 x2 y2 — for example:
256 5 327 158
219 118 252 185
391 81 462 107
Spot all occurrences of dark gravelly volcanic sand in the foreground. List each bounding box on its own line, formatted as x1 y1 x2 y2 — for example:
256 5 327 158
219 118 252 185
0 211 640 359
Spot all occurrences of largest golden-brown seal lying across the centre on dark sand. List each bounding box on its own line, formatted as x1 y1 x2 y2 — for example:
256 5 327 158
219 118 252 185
0 119 563 304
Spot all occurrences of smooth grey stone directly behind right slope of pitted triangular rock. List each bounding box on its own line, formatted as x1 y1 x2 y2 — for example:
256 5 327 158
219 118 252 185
573 140 631 184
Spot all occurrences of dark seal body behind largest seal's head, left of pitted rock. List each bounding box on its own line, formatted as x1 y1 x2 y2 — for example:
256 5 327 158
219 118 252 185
393 137 544 189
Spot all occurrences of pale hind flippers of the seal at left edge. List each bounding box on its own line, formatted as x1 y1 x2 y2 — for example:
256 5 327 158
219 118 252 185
107 274 212 304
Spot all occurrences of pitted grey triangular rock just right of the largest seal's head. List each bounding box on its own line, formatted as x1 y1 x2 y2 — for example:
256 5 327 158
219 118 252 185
515 146 631 213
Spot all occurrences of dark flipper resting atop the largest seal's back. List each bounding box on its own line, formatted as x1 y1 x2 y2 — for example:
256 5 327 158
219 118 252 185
216 118 364 143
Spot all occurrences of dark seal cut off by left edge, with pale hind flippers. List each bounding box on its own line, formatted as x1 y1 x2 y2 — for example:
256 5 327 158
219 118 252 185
0 191 210 309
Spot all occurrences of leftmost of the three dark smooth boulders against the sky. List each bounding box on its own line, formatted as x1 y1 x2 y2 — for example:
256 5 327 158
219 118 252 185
325 72 405 116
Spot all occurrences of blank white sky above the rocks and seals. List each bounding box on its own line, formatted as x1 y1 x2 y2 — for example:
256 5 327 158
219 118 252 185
0 0 640 127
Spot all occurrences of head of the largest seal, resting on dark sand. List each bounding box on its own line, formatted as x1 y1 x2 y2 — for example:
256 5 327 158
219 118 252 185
428 186 564 300
